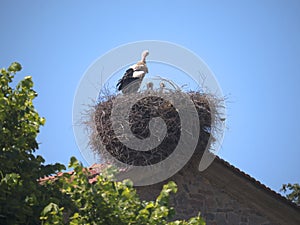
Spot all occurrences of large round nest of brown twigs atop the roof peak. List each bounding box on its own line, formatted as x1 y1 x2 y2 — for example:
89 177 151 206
88 88 220 166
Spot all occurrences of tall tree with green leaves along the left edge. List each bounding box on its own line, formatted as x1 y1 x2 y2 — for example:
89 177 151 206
0 62 64 224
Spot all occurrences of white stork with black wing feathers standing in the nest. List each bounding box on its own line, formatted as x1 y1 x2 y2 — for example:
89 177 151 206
116 50 149 94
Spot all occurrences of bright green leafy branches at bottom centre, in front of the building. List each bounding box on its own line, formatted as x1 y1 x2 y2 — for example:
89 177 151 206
41 157 205 225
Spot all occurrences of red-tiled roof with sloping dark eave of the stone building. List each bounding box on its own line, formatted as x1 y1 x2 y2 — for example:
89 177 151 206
40 156 300 224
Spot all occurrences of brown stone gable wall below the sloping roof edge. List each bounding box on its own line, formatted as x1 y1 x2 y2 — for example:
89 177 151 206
137 151 279 225
